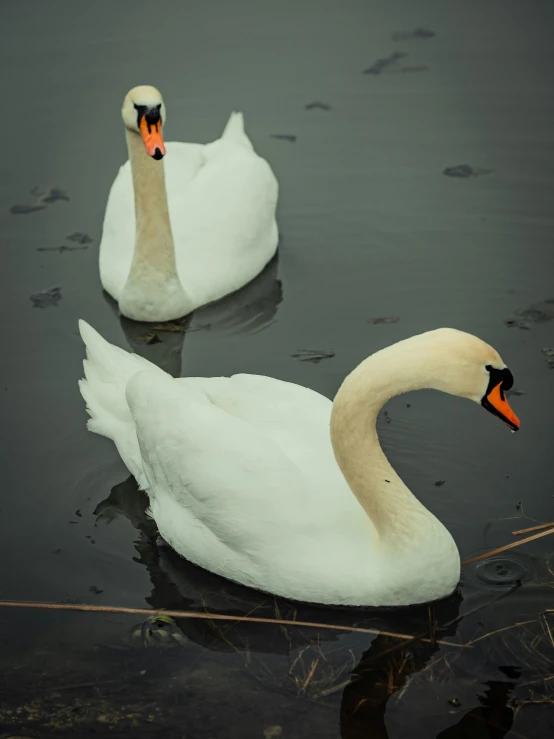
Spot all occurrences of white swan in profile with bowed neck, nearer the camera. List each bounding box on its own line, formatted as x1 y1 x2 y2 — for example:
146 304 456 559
80 321 519 606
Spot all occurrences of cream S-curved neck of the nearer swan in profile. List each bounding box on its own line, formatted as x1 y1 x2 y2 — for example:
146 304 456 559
331 337 442 546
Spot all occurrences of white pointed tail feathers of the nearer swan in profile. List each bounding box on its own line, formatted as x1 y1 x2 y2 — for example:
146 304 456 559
79 320 165 447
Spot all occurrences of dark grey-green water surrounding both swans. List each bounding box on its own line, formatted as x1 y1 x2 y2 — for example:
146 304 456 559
0 0 554 739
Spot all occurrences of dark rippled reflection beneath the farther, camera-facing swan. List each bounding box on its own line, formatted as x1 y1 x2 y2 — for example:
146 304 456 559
104 252 283 377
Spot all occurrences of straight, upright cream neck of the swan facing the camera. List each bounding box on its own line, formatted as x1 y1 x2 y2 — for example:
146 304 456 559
125 129 177 281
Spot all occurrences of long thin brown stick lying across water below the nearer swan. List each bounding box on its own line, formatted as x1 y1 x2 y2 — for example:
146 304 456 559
0 600 464 647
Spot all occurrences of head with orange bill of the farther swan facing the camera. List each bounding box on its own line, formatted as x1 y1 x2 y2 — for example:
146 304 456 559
121 85 166 159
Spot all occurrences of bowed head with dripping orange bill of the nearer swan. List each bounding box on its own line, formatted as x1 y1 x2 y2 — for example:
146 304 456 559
422 328 520 431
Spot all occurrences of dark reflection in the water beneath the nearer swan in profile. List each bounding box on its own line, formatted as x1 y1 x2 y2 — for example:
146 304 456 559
95 477 470 739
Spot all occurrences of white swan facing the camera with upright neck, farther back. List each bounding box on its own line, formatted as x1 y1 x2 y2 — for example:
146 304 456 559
100 86 278 321
